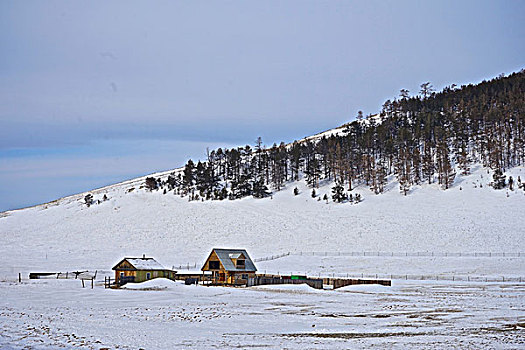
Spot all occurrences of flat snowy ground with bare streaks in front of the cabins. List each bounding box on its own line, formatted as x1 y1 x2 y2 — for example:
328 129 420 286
0 279 525 349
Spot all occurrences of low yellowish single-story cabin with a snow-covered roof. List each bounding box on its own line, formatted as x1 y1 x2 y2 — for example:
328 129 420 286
113 255 177 286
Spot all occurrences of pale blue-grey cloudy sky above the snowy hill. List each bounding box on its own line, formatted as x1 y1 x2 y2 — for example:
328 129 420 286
0 0 525 211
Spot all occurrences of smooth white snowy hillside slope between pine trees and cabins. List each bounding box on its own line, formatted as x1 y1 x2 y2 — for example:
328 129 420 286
0 162 525 276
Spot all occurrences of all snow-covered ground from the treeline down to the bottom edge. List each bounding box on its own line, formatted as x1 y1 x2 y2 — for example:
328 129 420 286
0 168 525 349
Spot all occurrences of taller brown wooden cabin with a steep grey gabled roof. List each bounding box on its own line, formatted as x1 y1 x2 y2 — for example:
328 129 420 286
201 248 257 285
